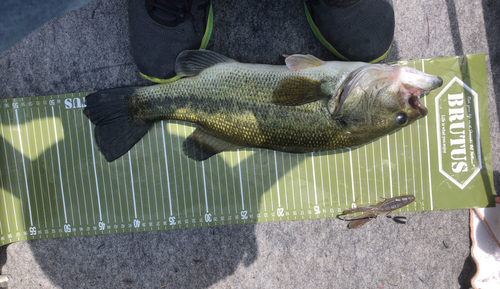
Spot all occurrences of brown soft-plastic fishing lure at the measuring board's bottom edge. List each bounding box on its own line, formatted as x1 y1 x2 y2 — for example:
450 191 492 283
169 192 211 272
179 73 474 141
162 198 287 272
337 195 415 229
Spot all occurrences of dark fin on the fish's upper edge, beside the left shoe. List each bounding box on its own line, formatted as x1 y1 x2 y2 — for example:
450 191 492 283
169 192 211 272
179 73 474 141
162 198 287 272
175 49 236 77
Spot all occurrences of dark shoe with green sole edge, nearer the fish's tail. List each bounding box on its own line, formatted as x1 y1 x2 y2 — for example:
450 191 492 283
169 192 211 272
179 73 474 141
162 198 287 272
128 0 213 83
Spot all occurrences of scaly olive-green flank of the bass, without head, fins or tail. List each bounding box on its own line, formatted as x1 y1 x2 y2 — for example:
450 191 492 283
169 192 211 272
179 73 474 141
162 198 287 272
135 63 350 150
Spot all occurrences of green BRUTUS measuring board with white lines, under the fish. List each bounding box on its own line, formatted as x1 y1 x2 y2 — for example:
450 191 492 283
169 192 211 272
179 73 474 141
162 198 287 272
0 54 494 245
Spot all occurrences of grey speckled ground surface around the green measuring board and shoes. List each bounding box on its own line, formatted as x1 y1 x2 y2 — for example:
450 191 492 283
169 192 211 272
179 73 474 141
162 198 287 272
0 0 500 288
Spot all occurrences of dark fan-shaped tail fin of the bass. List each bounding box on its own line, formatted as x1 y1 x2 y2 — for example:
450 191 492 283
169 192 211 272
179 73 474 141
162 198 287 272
83 87 153 162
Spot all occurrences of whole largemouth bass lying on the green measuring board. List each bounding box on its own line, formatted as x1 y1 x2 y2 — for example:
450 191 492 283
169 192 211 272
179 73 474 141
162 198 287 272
83 50 443 162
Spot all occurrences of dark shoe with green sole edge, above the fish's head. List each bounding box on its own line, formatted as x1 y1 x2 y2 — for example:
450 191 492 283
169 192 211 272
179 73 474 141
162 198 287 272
304 0 394 62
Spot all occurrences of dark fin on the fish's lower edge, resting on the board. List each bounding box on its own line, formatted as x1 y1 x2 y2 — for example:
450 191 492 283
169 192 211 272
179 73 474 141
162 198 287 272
182 128 242 161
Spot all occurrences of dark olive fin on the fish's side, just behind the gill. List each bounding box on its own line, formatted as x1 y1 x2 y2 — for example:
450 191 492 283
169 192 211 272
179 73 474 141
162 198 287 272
273 76 328 106
